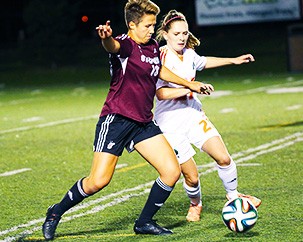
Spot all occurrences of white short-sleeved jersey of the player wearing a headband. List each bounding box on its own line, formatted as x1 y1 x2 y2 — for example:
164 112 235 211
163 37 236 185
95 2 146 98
155 45 206 132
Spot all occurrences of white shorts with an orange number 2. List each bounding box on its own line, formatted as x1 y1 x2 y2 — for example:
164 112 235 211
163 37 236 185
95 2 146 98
164 112 220 164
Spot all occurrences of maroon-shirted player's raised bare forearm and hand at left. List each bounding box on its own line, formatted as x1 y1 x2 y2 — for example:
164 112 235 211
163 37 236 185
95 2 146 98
96 20 120 53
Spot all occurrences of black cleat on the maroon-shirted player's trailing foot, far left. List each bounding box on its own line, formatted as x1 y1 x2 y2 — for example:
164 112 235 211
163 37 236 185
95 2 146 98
42 204 61 240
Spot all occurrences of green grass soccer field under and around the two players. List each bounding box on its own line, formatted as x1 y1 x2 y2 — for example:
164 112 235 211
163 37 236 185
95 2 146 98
0 66 303 242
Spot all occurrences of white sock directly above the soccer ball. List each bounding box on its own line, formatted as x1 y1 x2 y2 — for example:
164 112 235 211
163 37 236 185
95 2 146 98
217 159 238 199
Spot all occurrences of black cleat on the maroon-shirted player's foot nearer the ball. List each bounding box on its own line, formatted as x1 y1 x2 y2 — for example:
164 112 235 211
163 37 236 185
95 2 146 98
134 220 173 235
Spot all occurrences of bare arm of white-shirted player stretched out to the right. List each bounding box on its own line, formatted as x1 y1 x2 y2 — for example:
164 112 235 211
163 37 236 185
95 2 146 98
205 54 255 69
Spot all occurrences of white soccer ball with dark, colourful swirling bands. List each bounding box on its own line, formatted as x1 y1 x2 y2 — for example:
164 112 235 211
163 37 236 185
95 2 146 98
222 197 258 232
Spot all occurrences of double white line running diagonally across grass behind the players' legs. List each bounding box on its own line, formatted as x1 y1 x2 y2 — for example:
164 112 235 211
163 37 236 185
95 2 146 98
0 132 303 242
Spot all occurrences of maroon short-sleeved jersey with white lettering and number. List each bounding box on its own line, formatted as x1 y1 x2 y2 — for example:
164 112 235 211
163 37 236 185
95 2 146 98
100 34 161 123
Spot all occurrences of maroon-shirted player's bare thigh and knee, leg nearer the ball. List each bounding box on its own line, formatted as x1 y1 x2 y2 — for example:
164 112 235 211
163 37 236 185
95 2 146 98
134 134 180 182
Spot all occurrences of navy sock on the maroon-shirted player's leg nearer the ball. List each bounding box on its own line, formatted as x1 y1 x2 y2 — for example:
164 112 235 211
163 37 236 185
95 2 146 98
136 177 173 226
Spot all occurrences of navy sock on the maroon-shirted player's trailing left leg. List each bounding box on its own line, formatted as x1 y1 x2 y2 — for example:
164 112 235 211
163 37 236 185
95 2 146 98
54 178 89 216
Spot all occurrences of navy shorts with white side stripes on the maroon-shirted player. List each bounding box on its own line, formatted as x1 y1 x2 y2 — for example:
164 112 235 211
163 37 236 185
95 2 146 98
93 114 162 156
